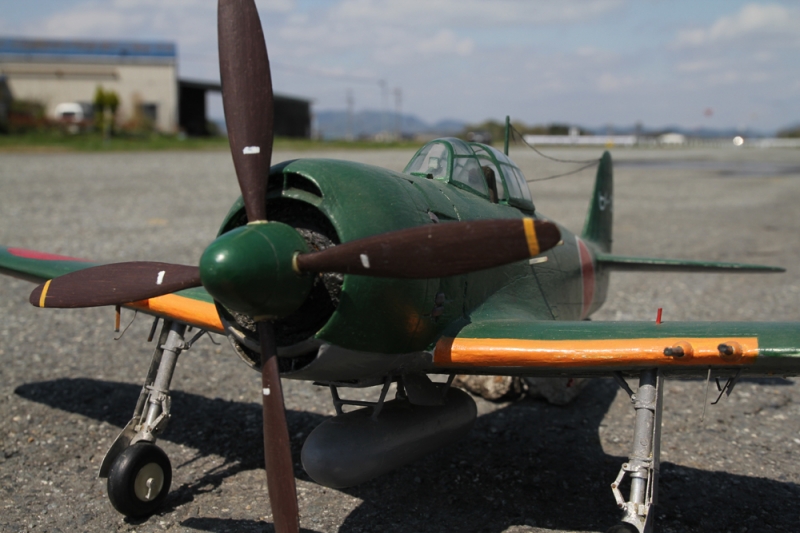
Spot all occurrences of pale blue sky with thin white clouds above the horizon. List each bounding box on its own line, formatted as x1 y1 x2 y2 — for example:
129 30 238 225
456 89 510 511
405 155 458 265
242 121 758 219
0 0 800 130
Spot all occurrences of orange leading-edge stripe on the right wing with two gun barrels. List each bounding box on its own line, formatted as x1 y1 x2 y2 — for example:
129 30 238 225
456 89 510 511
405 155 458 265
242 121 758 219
433 337 758 367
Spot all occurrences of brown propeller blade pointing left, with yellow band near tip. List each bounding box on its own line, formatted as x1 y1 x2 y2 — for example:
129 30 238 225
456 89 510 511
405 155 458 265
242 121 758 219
30 261 201 308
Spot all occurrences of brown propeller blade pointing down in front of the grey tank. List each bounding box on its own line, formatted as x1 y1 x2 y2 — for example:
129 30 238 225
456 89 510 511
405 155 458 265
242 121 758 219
257 321 300 533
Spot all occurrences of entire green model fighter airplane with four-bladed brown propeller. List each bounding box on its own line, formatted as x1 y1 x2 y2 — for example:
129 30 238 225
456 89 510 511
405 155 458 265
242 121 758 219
0 4 800 533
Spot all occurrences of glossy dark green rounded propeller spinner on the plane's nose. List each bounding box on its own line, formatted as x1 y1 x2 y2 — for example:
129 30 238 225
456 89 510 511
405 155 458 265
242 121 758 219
200 222 314 320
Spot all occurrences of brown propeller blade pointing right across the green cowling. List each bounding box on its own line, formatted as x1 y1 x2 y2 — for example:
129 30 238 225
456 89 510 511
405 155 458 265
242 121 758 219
296 218 561 278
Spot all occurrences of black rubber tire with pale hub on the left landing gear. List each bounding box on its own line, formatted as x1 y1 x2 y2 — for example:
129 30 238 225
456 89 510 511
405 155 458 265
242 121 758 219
108 442 172 518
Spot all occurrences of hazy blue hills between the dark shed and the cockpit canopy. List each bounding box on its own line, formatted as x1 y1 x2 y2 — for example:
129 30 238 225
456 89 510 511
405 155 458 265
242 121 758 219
314 111 466 139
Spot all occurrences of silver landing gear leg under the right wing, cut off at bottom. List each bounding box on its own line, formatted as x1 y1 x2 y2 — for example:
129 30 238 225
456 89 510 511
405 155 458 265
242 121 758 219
608 369 664 533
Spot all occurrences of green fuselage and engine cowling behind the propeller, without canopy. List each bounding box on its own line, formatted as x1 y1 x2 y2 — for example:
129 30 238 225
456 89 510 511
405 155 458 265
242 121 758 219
221 159 607 354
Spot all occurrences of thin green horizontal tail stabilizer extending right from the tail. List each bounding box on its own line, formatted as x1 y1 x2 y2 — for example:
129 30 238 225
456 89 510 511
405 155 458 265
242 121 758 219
595 254 786 272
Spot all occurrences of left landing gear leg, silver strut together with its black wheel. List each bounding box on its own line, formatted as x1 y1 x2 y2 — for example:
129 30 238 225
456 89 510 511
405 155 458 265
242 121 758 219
99 321 188 518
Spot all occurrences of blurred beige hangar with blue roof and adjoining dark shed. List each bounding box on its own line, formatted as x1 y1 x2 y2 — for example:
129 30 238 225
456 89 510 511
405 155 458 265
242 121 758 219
0 38 311 137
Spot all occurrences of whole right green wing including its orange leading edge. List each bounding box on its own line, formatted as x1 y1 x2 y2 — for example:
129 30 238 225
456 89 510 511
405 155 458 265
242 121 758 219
434 318 800 377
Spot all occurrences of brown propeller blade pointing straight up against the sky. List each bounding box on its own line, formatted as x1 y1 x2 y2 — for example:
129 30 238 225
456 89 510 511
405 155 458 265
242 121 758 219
217 0 273 222
